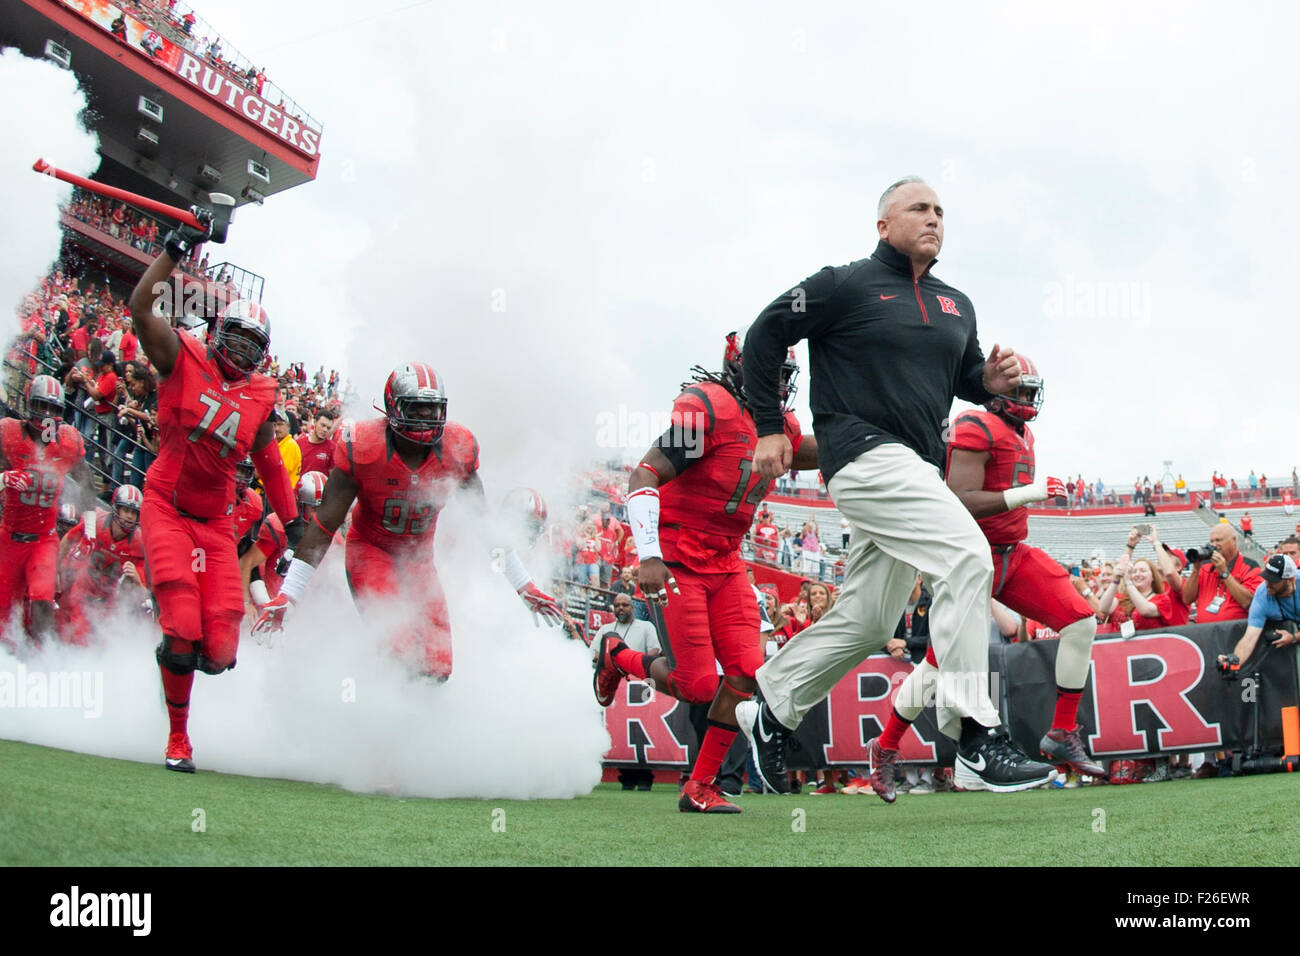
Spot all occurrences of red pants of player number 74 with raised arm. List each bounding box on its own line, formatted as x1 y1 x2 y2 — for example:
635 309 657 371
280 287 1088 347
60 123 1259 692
140 490 244 667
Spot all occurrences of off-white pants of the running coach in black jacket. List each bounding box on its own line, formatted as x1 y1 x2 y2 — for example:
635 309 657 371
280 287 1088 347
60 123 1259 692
758 444 1000 739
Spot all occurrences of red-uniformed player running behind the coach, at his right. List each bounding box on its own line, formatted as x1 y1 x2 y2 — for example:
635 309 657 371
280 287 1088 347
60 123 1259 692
867 355 1105 804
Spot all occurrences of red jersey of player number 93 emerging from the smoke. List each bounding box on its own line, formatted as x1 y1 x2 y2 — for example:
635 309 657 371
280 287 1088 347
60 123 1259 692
334 419 478 550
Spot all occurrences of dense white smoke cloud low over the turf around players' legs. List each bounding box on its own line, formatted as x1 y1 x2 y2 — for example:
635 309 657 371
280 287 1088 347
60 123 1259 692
0 506 608 800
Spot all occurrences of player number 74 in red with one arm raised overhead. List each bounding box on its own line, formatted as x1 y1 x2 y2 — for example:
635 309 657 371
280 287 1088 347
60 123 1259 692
130 209 303 774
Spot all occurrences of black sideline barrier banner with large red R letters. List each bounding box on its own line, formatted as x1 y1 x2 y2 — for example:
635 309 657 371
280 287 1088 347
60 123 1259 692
606 622 1300 769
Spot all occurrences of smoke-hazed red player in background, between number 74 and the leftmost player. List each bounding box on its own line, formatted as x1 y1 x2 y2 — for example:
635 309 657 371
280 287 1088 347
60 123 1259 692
55 485 146 645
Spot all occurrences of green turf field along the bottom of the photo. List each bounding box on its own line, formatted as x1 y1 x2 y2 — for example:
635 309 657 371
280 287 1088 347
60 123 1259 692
0 741 1300 866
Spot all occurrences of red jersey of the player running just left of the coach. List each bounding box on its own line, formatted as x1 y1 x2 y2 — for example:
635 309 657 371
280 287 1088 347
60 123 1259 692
659 382 802 572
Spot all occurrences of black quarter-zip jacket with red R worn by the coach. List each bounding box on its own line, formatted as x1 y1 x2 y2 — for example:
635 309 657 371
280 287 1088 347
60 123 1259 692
742 239 992 481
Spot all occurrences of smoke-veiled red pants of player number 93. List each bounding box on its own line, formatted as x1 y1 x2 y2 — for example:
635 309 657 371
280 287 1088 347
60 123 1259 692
343 537 451 678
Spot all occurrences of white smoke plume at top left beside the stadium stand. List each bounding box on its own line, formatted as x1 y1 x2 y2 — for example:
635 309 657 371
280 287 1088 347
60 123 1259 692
0 49 99 327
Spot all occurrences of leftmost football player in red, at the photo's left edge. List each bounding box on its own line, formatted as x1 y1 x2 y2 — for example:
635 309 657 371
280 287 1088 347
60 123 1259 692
0 375 90 643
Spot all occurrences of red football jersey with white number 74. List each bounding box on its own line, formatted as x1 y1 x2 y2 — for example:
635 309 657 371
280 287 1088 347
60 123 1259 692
146 336 276 518
